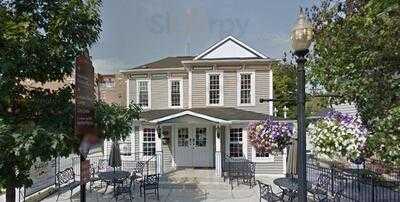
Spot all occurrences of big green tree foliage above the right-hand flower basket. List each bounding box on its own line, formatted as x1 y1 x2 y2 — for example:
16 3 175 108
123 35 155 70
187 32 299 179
310 0 400 131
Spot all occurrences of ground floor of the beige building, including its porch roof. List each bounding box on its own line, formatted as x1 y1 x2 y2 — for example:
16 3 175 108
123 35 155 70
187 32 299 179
105 107 283 176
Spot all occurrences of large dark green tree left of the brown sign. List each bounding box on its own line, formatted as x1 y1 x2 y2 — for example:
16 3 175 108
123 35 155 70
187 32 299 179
0 0 101 201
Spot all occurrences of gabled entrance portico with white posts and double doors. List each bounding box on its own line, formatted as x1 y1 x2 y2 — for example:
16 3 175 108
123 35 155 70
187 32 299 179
150 111 229 175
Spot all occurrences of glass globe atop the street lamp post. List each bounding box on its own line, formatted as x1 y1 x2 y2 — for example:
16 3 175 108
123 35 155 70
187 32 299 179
290 9 314 52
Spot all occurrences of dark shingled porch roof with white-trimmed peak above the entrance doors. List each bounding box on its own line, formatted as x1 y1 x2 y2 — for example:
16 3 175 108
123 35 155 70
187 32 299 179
141 107 276 123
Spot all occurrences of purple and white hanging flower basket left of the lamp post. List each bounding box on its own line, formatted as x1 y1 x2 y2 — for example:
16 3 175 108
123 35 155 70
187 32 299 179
248 119 293 154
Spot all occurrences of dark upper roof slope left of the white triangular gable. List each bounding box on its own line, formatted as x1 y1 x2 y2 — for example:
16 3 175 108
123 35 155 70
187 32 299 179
131 56 194 69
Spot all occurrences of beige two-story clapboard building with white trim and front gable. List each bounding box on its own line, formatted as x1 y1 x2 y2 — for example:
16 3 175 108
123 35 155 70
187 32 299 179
105 36 285 175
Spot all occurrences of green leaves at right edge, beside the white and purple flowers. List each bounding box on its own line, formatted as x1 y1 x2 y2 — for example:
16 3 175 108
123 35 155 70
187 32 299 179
367 105 400 166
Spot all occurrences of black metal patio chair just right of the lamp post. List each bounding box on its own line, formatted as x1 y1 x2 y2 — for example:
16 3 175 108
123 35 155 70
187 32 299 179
308 173 332 201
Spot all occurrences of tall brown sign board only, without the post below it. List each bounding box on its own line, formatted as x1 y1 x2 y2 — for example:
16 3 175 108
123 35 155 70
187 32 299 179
75 55 95 138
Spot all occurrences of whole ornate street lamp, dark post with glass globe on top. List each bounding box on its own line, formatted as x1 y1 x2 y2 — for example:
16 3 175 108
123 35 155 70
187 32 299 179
291 9 313 201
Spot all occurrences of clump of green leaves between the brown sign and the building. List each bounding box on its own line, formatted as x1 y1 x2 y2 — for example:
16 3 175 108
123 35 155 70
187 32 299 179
95 101 141 140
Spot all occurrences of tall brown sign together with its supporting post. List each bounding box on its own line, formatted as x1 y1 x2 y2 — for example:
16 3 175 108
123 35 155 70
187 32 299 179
75 53 96 202
